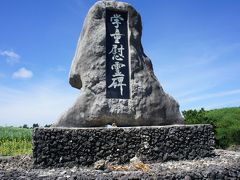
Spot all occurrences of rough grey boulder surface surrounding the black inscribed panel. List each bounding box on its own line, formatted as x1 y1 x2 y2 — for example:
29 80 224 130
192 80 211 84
53 1 183 127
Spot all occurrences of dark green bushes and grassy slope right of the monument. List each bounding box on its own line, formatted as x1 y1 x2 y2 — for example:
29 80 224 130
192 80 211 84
183 107 240 148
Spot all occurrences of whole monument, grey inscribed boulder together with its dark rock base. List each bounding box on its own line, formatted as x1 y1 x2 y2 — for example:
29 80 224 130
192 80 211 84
33 1 214 167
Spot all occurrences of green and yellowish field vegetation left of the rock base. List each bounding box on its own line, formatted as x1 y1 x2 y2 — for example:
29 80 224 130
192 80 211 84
0 127 32 156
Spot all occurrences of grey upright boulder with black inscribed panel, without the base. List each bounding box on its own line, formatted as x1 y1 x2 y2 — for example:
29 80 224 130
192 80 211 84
53 1 183 127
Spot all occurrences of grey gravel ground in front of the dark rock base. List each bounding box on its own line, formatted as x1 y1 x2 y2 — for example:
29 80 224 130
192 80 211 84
0 150 240 180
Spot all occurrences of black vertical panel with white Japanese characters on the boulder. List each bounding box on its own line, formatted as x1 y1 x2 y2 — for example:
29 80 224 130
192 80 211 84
106 9 130 99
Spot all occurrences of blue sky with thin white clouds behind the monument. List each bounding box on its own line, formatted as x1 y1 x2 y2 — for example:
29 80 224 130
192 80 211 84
0 0 240 126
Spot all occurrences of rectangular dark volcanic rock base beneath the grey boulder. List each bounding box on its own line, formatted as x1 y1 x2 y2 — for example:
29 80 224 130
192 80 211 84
33 125 214 167
